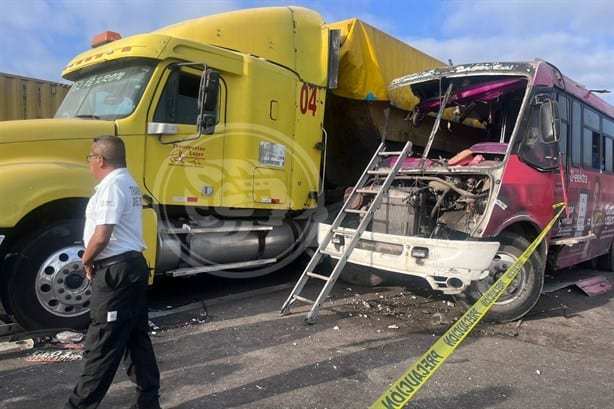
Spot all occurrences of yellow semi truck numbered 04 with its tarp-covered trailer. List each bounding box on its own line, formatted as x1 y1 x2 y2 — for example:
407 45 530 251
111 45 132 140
0 7 444 329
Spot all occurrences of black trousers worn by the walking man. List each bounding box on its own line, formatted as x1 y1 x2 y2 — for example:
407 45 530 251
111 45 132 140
65 255 160 409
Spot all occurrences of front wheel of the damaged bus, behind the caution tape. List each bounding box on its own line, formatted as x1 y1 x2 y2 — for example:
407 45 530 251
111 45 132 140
458 233 545 322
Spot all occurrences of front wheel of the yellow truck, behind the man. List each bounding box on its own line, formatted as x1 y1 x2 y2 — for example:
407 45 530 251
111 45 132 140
8 220 91 330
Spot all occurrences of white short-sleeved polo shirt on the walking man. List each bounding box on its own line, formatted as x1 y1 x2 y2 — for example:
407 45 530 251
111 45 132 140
83 168 146 260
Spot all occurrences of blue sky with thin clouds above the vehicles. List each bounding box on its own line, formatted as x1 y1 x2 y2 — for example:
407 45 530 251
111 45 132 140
0 0 614 103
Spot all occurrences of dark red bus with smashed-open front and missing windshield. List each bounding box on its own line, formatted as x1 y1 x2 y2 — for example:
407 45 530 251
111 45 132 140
320 60 614 321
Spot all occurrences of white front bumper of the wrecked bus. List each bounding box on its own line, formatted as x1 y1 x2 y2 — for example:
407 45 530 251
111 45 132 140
318 223 499 294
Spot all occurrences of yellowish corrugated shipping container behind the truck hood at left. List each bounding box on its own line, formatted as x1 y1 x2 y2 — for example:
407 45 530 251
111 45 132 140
0 72 70 121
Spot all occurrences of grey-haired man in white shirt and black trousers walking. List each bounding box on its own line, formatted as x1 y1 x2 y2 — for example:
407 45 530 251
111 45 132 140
65 135 160 409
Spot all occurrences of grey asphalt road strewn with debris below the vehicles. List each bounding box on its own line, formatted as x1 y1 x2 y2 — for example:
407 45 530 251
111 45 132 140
0 266 614 409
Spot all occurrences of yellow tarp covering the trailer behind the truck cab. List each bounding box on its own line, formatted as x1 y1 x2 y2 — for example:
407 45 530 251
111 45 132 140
327 18 446 106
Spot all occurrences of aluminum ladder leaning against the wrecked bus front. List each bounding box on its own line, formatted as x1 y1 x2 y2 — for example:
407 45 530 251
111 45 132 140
280 141 412 324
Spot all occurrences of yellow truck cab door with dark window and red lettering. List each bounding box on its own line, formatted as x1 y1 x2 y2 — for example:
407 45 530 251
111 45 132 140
144 68 225 206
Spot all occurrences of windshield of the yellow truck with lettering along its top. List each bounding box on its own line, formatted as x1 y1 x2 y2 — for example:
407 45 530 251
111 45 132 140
55 61 153 120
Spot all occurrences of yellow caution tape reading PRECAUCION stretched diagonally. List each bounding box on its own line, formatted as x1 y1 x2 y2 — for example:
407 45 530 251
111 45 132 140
370 203 565 409
